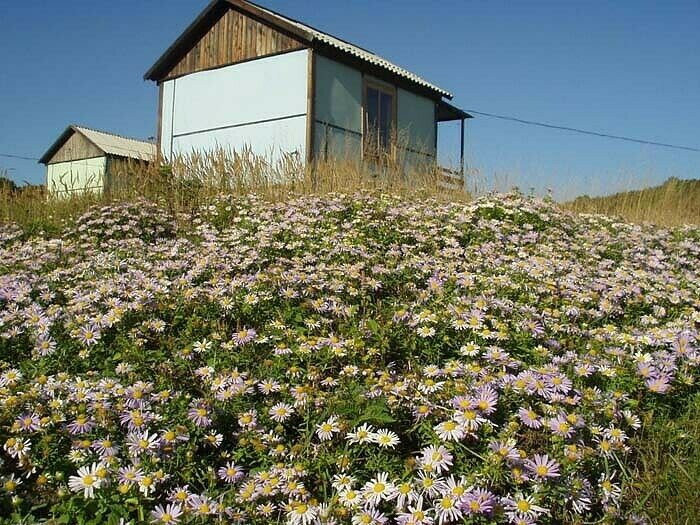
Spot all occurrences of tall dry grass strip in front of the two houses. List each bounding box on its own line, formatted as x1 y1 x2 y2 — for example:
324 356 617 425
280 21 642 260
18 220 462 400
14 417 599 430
0 149 470 230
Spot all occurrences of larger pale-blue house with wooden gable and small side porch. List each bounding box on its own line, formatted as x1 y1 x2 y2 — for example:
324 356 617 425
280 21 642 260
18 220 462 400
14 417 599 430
145 0 471 174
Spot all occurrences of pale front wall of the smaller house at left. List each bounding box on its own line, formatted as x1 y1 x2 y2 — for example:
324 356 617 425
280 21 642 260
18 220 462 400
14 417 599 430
46 157 107 197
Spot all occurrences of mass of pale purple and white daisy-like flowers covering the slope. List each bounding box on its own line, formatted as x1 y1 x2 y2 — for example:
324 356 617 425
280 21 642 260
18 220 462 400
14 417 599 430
0 194 700 525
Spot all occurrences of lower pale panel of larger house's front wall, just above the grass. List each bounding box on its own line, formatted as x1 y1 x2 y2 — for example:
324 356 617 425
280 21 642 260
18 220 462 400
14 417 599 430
173 115 306 167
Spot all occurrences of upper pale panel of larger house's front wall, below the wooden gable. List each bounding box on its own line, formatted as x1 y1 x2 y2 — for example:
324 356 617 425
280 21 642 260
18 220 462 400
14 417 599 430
172 49 308 137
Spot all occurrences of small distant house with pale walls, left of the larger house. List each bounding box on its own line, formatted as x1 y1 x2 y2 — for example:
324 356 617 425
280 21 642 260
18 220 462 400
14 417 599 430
39 125 157 197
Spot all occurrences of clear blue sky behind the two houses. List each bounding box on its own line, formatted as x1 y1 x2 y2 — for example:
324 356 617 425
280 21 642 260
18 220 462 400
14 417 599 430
0 0 700 196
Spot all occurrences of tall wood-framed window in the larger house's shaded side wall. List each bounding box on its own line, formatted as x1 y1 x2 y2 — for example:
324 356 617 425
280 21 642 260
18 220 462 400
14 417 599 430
364 82 396 159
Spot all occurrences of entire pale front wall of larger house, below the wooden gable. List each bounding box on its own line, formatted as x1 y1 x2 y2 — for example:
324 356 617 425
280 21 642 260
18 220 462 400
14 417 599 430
161 49 308 162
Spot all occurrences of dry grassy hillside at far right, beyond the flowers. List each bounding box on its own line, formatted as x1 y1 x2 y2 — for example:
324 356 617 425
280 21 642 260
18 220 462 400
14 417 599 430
567 178 700 224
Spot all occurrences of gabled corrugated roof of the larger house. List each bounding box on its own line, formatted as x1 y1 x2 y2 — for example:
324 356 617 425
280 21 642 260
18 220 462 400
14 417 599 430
144 0 452 99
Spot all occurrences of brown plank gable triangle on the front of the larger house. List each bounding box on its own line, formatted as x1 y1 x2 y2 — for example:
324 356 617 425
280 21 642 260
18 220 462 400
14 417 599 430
163 8 304 80
